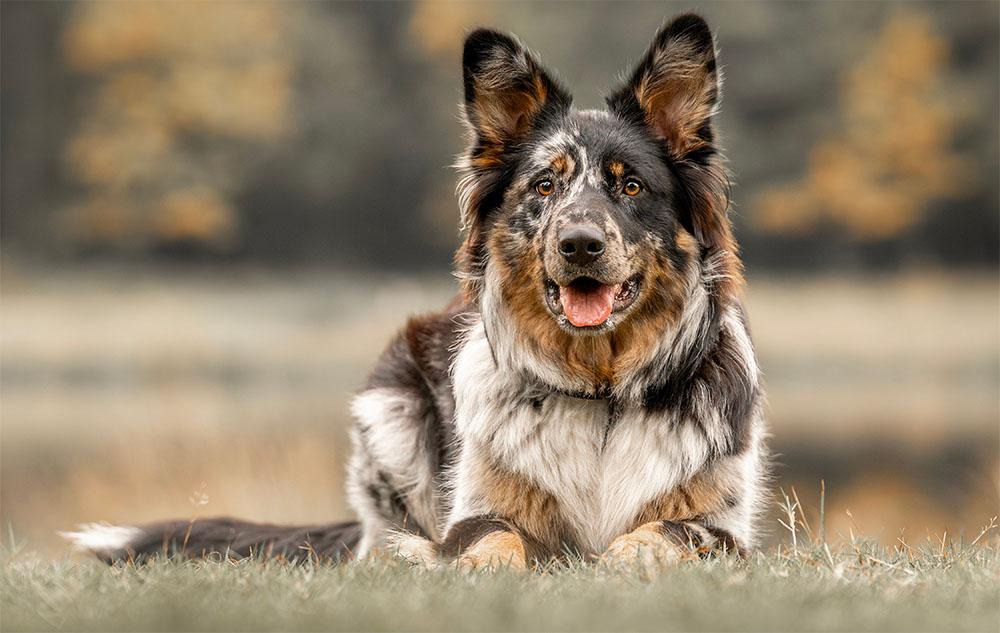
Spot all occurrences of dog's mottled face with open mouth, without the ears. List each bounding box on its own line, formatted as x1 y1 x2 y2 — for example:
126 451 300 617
500 112 694 335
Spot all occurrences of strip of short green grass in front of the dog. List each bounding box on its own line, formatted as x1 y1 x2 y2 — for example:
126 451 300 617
0 537 1000 631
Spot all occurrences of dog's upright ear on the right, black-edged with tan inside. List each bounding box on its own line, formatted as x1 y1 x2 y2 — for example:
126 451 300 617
607 13 720 159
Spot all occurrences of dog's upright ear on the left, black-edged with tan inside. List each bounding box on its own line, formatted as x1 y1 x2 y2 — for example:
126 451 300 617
462 29 572 163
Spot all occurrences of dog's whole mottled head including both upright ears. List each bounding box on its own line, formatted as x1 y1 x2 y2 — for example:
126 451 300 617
457 15 733 366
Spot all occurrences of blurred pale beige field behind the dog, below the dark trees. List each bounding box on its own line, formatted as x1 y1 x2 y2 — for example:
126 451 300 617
0 268 1000 554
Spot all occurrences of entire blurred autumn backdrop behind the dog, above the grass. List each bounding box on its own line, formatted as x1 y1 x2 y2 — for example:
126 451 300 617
0 0 1000 555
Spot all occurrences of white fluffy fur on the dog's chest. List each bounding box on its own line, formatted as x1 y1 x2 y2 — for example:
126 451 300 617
449 329 709 552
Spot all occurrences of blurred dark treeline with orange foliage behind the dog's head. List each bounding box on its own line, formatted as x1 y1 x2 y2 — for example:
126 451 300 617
0 0 1000 270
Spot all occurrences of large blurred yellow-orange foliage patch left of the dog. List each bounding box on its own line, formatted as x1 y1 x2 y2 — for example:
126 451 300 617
62 2 292 249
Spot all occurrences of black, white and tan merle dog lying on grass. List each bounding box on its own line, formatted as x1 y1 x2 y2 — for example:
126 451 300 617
70 15 766 568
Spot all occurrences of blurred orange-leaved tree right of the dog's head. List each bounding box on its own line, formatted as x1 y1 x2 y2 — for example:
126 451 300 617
752 11 969 239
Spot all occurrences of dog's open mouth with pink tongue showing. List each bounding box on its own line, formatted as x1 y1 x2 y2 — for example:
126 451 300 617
545 276 641 328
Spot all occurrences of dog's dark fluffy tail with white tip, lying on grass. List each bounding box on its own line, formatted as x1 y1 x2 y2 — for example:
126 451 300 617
62 518 361 563
